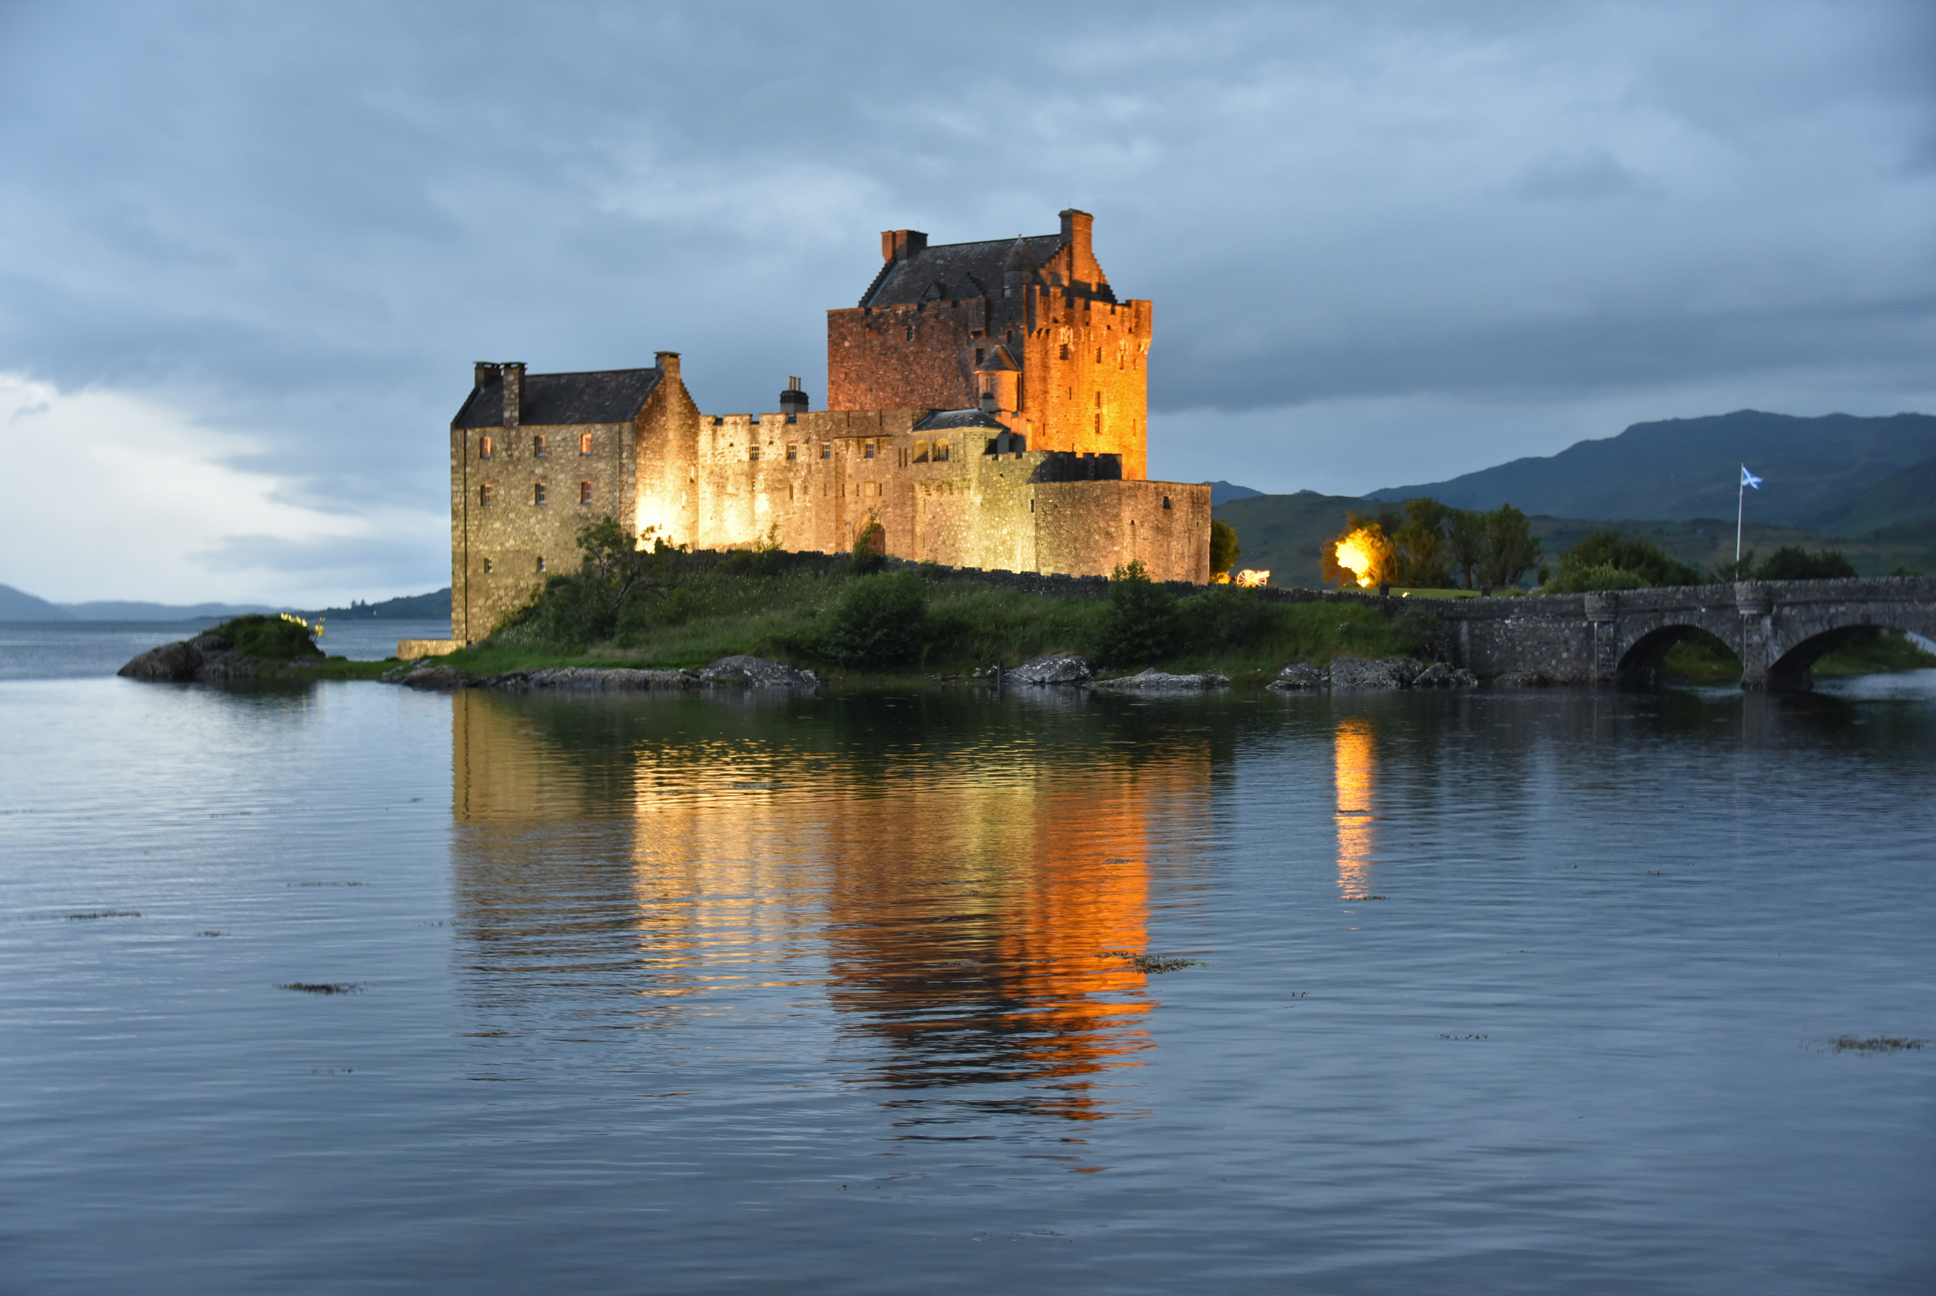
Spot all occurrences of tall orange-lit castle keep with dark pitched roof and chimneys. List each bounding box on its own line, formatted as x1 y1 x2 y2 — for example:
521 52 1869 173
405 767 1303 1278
827 209 1152 480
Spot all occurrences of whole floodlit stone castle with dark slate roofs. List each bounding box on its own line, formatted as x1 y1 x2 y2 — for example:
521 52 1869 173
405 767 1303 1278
451 211 1210 643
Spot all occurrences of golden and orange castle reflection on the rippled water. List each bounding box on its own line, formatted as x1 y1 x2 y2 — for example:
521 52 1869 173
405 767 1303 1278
453 692 1210 1120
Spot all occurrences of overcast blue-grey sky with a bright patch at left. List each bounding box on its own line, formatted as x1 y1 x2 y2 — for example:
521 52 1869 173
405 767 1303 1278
0 0 1936 604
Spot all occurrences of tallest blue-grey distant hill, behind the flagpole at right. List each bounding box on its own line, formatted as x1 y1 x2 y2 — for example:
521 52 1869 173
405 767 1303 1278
1371 409 1936 527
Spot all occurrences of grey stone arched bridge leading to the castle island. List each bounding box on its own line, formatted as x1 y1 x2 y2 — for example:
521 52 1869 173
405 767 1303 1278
1431 575 1936 692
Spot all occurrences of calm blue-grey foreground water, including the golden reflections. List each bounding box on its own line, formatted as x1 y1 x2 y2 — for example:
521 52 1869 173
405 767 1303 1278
0 674 1936 1296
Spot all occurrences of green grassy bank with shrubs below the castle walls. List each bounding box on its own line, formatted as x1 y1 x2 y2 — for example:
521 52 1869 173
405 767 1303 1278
445 556 1431 682
